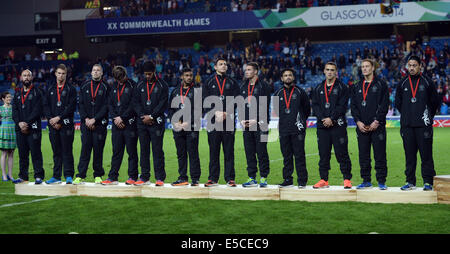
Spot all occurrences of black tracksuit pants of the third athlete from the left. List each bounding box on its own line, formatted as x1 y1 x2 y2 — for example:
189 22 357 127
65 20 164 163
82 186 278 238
77 123 108 178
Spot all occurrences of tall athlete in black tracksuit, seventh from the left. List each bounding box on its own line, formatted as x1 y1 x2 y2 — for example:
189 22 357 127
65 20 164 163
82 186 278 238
202 67 239 187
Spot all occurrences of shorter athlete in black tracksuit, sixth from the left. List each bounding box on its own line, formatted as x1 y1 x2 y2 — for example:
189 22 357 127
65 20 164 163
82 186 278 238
169 74 202 186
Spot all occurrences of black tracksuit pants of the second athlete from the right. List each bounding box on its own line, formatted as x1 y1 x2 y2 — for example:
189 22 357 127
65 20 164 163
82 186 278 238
356 126 387 184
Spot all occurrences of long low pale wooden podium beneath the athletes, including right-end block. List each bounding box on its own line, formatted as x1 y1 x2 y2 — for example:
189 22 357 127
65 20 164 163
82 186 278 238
15 175 450 204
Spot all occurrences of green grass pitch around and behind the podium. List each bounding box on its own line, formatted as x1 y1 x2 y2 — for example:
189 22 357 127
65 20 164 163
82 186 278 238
0 128 450 234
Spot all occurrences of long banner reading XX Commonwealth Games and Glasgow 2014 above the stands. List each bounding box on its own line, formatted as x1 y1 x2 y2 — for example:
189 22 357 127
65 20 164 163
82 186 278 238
86 1 450 36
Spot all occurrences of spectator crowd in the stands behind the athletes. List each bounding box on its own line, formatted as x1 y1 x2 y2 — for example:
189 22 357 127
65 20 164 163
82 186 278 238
0 38 450 115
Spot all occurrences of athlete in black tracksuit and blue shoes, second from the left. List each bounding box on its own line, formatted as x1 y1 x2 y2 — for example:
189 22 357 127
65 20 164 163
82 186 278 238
44 78 77 180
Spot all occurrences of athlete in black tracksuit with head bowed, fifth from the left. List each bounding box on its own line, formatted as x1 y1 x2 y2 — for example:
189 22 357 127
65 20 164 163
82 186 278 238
133 65 169 186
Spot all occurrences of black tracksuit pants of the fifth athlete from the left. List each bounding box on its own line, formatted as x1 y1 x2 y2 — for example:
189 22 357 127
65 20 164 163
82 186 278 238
138 125 166 181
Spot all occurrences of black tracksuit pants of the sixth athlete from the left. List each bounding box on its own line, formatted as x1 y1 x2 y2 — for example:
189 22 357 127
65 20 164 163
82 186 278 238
173 130 201 181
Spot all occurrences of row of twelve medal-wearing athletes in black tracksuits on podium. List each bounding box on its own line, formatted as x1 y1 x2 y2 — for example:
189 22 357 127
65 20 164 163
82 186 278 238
12 56 439 190
